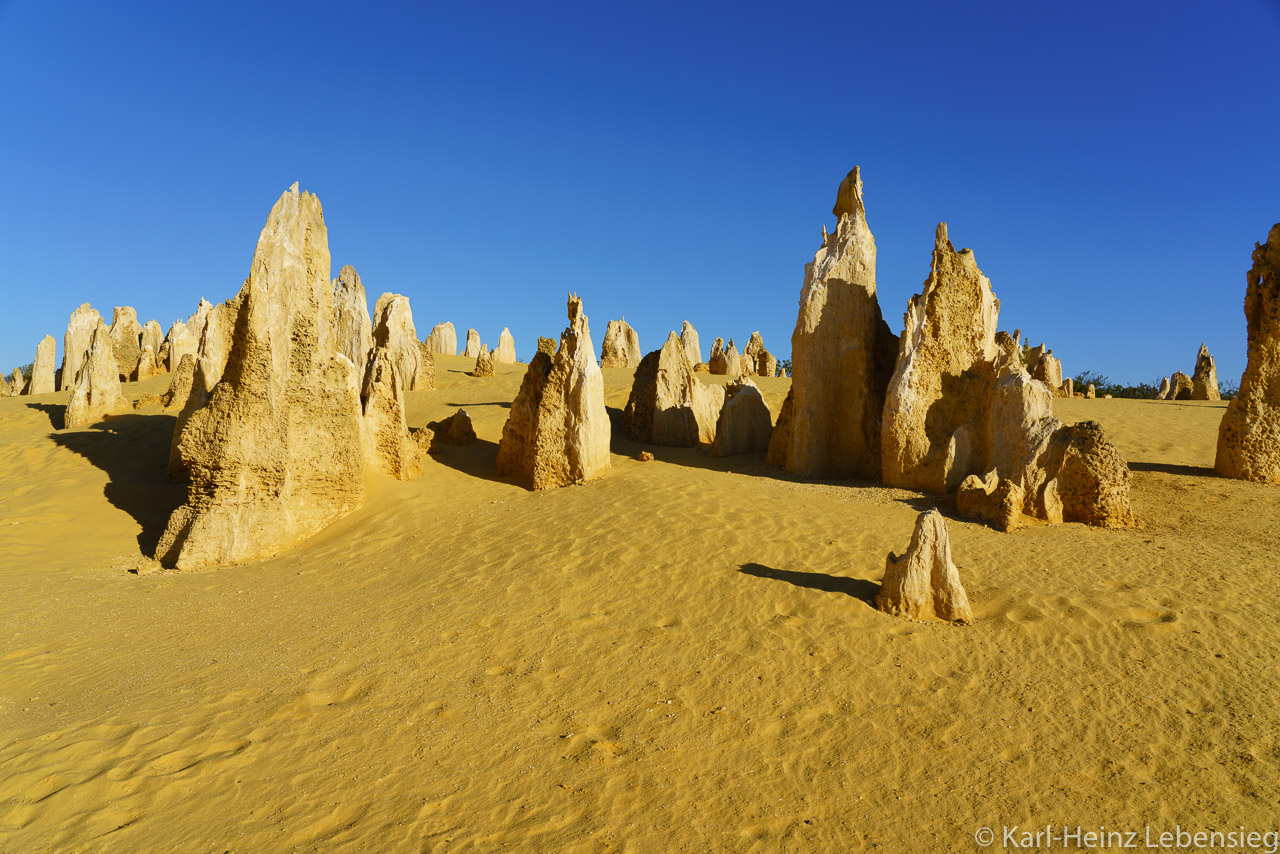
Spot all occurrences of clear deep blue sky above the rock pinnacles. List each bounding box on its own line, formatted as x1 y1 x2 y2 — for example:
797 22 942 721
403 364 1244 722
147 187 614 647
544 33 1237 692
0 0 1280 382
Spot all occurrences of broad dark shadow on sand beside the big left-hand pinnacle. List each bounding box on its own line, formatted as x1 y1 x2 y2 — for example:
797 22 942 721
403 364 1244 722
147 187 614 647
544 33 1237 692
49 412 187 556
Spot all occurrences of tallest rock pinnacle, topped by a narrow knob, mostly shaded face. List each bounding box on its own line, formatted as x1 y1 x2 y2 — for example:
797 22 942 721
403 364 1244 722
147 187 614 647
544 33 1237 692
762 166 899 480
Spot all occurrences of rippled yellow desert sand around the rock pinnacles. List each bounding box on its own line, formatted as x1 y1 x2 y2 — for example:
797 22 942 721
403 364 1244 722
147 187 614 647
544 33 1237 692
0 359 1280 854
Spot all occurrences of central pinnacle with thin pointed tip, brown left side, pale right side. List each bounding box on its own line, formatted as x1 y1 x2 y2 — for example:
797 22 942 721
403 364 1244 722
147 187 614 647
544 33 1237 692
498 296 609 489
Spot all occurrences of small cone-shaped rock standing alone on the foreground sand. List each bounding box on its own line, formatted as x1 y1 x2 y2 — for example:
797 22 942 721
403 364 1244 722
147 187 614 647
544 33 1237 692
876 510 973 622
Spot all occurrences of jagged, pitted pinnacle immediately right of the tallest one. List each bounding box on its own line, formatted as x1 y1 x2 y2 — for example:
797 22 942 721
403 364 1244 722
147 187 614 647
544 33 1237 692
880 223 1000 493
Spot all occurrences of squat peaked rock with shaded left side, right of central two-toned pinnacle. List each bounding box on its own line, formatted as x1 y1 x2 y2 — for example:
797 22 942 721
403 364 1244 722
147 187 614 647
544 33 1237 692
622 333 724 448
